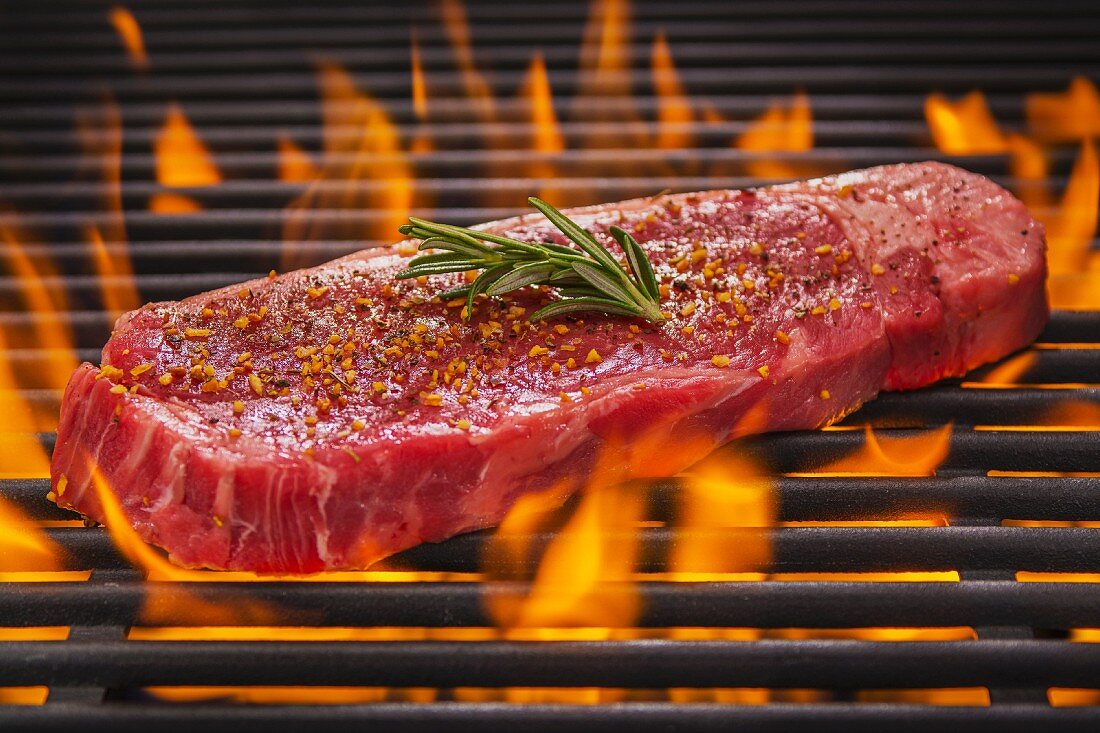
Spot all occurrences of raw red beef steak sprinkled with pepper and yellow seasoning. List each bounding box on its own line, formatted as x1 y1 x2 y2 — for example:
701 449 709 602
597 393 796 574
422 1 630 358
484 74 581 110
53 163 1047 573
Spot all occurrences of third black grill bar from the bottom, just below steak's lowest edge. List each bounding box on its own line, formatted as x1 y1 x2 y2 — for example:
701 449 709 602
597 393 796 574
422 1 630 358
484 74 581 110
0 580 1100 630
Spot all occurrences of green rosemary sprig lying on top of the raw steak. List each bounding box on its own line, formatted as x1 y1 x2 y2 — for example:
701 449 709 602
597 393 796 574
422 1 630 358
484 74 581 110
397 196 664 324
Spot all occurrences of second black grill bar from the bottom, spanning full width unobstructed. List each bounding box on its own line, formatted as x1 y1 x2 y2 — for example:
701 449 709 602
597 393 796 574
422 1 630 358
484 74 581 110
8 639 1100 689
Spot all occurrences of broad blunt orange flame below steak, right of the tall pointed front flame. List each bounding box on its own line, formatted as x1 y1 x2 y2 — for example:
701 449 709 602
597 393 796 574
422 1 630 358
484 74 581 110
670 451 778 580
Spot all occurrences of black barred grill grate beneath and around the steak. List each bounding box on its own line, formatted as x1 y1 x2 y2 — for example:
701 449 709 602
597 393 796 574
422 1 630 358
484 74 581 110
0 0 1100 731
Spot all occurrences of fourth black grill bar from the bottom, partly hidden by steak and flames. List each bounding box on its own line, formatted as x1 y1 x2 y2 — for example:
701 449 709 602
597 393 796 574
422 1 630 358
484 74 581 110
32 526 1100 573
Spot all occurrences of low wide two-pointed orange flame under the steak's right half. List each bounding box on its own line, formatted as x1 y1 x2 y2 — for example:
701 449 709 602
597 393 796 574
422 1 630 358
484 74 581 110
807 425 952 477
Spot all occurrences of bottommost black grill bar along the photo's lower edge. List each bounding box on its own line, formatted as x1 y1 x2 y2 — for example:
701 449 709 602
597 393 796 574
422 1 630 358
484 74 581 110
6 702 1100 733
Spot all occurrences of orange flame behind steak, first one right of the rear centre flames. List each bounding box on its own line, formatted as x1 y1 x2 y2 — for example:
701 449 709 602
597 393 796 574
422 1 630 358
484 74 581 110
735 91 814 178
